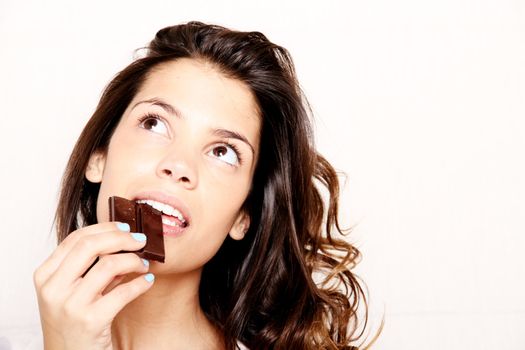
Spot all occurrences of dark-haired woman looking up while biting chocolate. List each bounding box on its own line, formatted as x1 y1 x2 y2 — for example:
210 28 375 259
34 22 366 349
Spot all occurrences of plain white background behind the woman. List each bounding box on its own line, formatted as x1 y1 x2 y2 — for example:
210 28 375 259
0 0 525 349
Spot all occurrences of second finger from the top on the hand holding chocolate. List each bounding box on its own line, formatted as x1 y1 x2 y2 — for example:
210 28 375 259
44 231 146 288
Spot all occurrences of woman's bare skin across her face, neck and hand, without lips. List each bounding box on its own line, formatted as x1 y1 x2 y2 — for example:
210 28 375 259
34 59 260 349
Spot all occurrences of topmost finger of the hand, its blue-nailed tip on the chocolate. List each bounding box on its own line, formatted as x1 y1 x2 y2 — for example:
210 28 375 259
33 222 129 287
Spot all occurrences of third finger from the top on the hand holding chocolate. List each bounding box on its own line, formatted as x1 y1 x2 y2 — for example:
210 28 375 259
71 253 149 304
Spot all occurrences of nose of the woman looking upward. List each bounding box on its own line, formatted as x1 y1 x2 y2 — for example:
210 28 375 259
157 151 198 189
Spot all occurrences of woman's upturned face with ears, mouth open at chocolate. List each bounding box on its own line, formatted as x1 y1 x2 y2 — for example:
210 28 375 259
86 59 260 272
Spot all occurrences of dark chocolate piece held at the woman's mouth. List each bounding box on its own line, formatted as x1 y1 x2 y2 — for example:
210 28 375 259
109 196 164 262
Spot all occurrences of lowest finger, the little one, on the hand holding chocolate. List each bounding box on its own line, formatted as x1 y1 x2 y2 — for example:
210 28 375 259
94 273 155 317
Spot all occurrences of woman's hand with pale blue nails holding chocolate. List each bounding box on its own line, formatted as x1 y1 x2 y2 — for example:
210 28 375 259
34 222 153 350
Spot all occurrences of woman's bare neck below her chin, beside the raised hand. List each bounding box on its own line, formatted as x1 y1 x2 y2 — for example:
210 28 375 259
112 271 223 349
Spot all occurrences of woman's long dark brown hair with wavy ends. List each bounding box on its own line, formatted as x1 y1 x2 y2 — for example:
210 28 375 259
56 22 367 349
